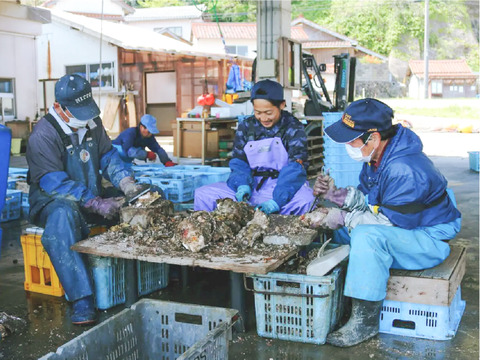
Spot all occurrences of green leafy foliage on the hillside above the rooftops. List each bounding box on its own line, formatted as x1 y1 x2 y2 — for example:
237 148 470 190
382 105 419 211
137 0 479 71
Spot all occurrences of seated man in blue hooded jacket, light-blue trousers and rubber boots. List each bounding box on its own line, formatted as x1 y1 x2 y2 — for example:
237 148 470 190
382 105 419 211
308 99 461 347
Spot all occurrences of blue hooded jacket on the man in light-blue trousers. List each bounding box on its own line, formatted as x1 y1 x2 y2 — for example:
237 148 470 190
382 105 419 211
358 125 461 229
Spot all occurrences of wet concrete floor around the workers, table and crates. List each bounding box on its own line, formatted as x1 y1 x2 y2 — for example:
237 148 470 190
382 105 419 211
0 150 479 360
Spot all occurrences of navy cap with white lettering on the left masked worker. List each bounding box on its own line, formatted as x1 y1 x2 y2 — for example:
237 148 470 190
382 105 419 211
55 74 100 120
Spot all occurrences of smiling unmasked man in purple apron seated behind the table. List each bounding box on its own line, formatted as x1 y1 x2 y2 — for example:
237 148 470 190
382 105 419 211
194 80 314 215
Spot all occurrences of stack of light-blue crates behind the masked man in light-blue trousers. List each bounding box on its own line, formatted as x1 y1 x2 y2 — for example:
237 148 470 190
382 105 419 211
323 112 363 187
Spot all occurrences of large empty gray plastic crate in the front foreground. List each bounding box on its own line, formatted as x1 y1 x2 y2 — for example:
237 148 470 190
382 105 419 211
40 299 238 360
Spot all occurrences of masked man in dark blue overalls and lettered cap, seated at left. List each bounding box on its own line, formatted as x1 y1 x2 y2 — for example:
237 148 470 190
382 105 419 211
27 75 149 324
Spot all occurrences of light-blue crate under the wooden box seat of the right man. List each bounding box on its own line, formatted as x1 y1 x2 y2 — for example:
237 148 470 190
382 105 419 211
379 286 465 340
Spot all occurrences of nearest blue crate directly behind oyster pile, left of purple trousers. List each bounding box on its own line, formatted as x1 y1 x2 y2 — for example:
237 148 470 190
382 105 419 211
138 172 195 202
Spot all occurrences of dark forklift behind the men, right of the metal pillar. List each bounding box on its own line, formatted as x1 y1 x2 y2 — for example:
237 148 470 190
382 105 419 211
302 53 356 179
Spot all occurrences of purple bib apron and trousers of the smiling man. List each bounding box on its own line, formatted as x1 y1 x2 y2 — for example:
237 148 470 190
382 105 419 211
194 137 314 215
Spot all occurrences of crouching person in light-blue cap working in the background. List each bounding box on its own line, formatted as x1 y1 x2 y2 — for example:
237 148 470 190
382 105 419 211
112 114 176 167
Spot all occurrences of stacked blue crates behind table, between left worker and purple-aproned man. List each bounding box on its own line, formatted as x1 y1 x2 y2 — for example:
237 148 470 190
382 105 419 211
133 164 230 211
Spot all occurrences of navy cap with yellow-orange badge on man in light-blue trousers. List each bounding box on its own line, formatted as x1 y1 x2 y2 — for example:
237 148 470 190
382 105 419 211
325 98 393 144
